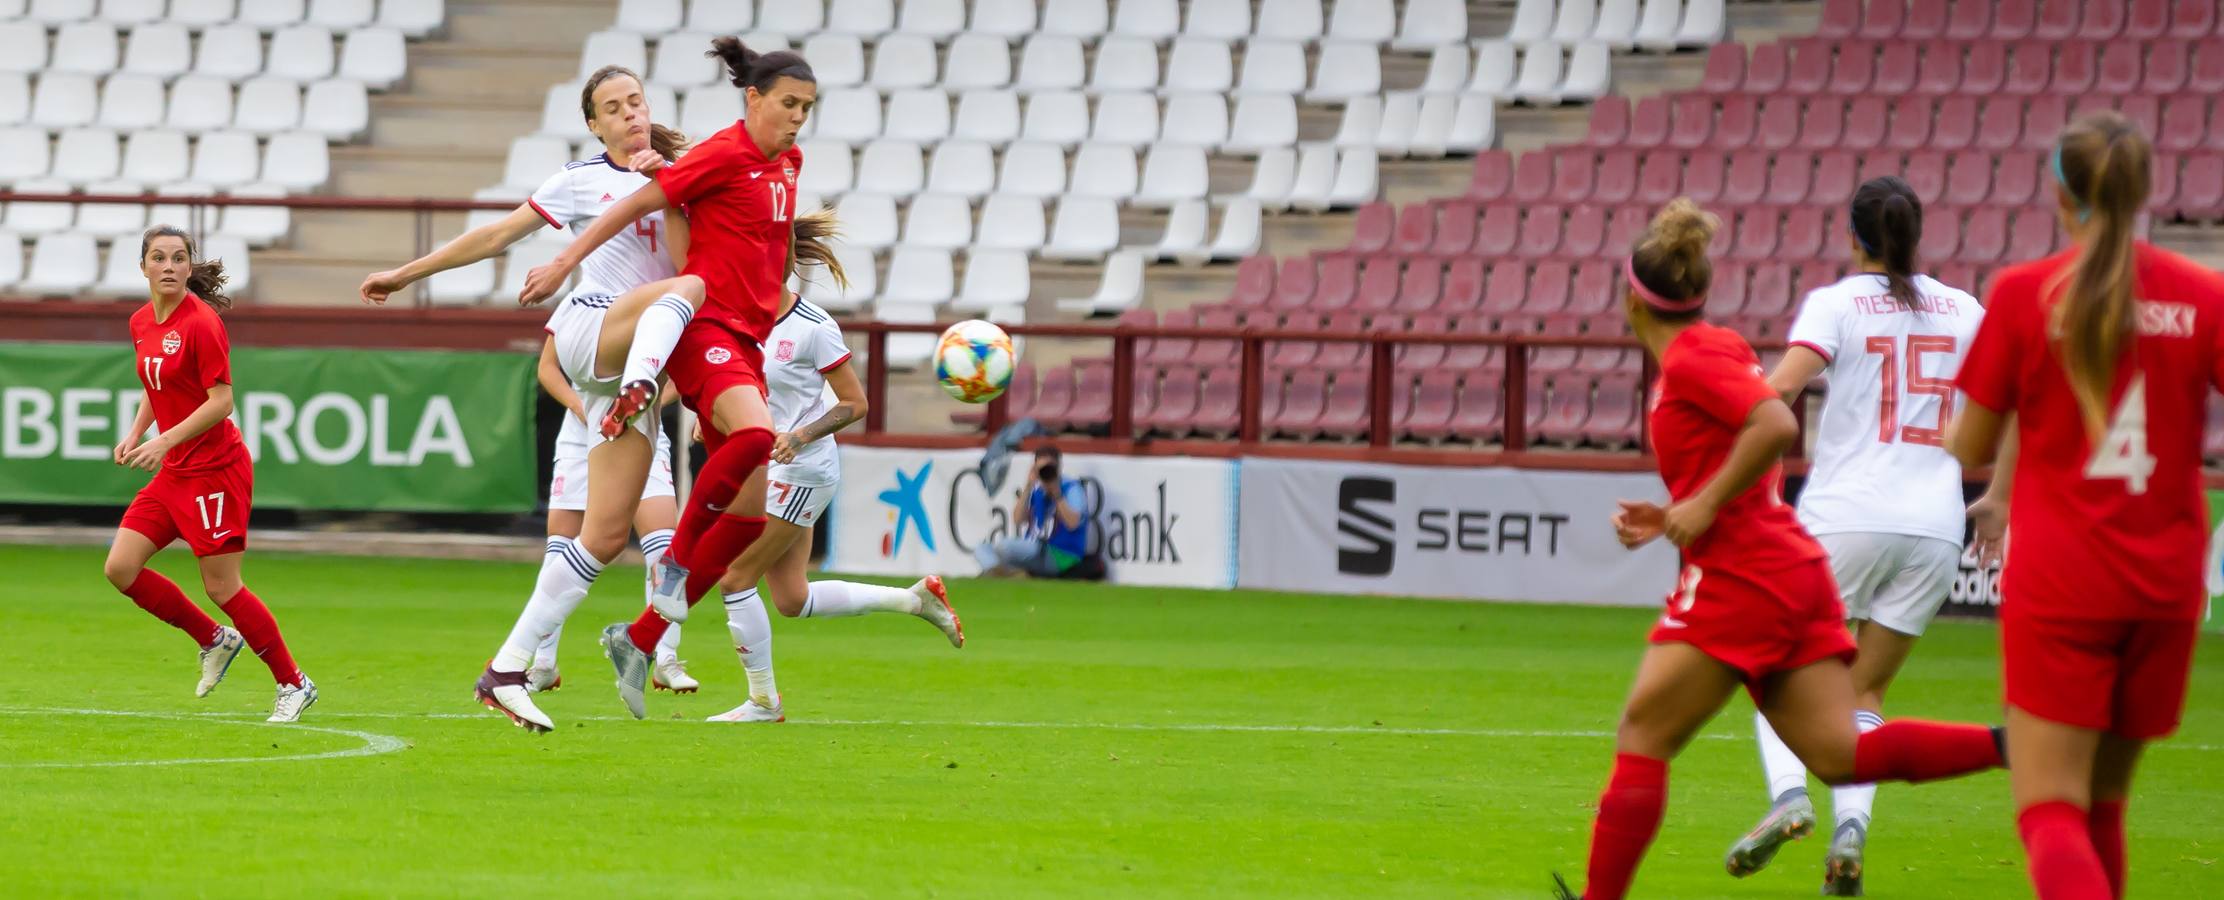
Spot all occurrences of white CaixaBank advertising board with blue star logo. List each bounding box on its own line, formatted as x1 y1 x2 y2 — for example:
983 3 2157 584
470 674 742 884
827 447 1237 587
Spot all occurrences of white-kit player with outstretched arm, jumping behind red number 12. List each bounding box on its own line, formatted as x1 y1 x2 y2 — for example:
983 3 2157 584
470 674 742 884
360 67 703 731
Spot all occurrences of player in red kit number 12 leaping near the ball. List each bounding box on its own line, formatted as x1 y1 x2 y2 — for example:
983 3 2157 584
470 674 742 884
518 38 818 718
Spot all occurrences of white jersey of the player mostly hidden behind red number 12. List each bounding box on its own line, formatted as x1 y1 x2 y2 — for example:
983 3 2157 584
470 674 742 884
765 298 850 487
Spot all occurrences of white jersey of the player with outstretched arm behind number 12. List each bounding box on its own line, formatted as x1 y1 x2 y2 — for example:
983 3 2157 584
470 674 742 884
527 153 678 296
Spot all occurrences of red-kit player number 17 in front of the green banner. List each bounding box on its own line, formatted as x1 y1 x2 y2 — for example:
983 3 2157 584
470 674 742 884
102 224 316 722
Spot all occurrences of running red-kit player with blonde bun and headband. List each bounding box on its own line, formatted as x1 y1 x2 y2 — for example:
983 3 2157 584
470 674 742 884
1561 198 2002 900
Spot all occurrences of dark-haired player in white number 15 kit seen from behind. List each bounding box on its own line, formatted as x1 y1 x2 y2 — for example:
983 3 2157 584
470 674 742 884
1728 178 1984 896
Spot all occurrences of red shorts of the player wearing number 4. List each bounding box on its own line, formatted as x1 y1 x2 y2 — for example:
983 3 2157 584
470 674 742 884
1999 600 2200 740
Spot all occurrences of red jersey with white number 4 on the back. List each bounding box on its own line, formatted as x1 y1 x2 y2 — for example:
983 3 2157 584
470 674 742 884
1957 242 2224 620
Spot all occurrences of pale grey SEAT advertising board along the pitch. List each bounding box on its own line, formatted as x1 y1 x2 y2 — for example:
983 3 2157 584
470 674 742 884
1239 458 1677 607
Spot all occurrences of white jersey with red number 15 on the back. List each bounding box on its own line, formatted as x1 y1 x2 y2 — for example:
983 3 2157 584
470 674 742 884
1790 273 1984 547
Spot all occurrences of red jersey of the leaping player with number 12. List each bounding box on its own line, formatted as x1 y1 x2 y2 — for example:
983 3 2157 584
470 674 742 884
656 122 803 344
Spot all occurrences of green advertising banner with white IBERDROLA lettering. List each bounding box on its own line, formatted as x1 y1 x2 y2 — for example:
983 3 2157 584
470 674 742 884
0 342 536 513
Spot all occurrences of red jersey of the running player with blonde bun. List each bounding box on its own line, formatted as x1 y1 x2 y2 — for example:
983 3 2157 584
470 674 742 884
1650 322 1824 582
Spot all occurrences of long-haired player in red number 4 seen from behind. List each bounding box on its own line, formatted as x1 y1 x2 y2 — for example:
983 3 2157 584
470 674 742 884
1946 113 2224 900
